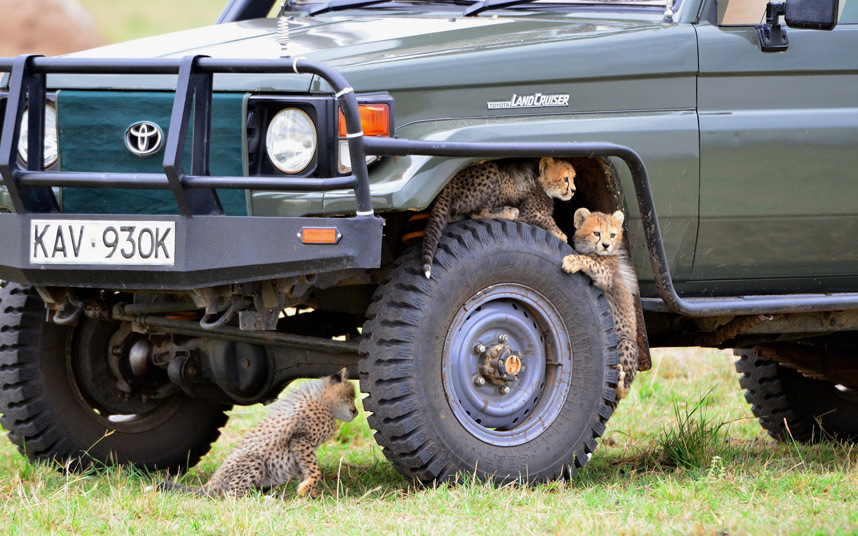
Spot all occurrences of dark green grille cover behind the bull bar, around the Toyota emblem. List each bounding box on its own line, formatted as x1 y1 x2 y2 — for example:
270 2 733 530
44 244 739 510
57 90 247 216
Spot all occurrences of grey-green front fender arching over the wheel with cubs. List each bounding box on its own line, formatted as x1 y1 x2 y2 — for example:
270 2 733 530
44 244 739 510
251 110 699 282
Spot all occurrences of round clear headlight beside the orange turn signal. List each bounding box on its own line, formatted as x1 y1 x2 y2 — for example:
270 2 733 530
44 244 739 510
265 108 316 174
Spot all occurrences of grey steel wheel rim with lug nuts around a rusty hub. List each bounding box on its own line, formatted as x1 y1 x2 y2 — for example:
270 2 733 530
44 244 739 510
441 283 572 446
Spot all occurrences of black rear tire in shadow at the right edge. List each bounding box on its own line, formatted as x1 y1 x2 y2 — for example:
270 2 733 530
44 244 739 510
734 349 858 443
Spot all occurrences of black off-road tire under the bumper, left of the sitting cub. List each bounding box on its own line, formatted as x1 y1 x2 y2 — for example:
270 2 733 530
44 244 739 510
0 281 228 472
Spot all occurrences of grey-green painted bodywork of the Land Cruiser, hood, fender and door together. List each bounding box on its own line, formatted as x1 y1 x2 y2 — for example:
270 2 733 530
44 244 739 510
1 0 858 295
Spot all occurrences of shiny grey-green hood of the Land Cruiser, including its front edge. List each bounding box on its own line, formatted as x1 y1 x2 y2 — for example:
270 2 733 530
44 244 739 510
49 14 680 91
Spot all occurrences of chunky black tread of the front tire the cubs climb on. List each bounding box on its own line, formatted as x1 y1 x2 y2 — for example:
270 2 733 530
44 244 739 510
359 219 618 484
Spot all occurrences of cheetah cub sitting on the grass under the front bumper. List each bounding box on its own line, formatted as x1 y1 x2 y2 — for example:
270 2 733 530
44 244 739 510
157 369 357 497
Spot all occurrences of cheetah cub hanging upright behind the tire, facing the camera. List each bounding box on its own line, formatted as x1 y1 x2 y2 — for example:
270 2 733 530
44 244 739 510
563 208 640 398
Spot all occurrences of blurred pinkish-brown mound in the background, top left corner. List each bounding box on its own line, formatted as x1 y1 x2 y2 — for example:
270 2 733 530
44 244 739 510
0 0 104 56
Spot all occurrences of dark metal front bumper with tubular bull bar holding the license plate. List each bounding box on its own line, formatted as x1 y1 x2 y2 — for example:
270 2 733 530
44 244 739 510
0 56 383 290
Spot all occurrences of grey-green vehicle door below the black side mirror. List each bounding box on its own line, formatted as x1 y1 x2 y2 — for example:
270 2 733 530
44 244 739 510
692 0 858 294
